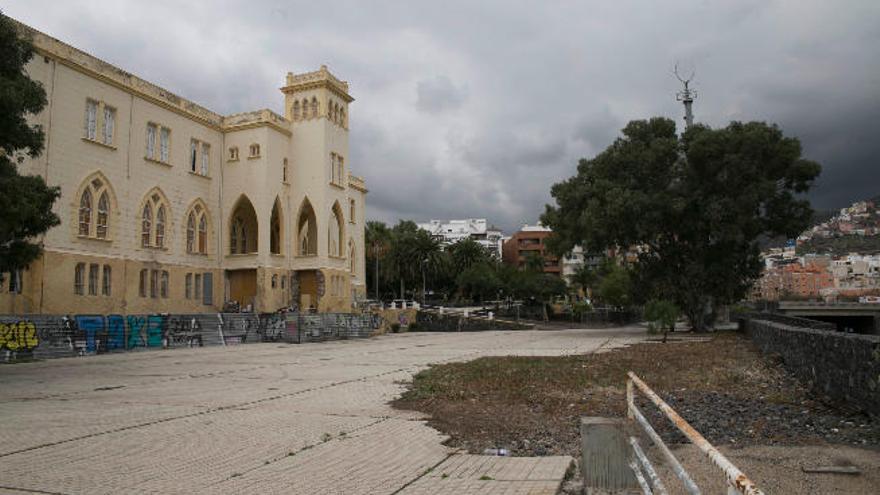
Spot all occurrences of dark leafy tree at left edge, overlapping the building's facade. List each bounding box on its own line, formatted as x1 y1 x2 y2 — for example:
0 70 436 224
0 13 60 275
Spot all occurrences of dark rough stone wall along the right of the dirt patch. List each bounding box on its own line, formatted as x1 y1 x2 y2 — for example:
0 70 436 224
741 317 880 417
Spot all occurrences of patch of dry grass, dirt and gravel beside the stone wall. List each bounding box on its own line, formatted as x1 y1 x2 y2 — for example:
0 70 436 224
393 333 880 456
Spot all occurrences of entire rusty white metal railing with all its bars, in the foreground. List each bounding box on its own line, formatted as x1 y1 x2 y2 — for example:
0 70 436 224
626 371 764 495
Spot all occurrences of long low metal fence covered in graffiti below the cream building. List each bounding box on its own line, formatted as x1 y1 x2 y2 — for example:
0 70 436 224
0 313 376 362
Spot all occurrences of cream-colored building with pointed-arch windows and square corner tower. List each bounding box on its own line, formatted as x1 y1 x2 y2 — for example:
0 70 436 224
0 20 367 313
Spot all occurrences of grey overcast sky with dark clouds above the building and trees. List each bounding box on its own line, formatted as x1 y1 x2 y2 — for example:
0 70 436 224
8 0 880 232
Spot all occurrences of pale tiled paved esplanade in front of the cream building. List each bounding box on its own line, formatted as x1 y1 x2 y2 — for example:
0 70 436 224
0 329 643 494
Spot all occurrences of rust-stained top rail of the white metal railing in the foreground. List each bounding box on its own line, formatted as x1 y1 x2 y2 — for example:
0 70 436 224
626 371 764 495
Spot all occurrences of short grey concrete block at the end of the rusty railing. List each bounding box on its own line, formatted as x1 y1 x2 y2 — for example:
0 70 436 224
581 416 639 495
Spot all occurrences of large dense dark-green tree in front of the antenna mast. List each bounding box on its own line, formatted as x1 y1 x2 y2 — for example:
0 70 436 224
542 118 821 330
